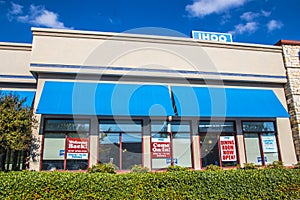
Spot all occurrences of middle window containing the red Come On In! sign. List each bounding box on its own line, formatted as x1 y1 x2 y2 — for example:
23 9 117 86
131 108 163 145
151 121 192 169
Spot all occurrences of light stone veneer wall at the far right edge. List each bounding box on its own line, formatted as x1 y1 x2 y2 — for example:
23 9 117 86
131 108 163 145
280 41 300 161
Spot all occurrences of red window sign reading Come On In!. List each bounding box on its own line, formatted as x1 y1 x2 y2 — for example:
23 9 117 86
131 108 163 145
151 139 171 158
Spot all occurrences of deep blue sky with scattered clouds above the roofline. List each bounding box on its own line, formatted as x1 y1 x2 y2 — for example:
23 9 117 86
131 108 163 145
0 0 300 45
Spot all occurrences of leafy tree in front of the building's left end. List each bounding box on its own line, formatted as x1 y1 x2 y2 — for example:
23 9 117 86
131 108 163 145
0 93 37 170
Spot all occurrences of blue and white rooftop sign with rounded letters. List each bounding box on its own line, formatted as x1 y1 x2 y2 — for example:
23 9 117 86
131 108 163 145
192 31 232 42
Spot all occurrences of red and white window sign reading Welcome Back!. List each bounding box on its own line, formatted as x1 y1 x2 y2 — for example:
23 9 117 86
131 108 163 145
67 138 89 159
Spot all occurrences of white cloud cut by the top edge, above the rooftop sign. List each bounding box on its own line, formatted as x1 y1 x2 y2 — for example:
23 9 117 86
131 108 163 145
185 0 248 17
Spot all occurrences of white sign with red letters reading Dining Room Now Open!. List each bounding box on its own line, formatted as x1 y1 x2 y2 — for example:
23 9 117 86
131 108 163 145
220 136 237 161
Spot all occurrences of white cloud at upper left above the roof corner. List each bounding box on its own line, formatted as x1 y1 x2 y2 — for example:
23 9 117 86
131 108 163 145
9 4 67 29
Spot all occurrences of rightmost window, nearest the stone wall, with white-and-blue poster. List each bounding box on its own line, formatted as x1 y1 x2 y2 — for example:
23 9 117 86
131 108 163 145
243 122 279 165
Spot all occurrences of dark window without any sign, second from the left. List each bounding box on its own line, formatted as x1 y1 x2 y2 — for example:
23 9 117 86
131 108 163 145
99 120 142 170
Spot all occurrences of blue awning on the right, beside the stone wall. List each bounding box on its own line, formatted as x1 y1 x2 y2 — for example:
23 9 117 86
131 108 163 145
172 86 289 118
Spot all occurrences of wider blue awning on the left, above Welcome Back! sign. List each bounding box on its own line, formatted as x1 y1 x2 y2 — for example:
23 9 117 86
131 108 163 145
36 82 174 116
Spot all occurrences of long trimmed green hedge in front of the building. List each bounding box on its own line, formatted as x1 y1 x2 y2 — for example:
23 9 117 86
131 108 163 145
0 169 300 199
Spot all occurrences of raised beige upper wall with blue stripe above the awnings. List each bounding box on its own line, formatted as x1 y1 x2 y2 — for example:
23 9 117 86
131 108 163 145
31 28 286 83
